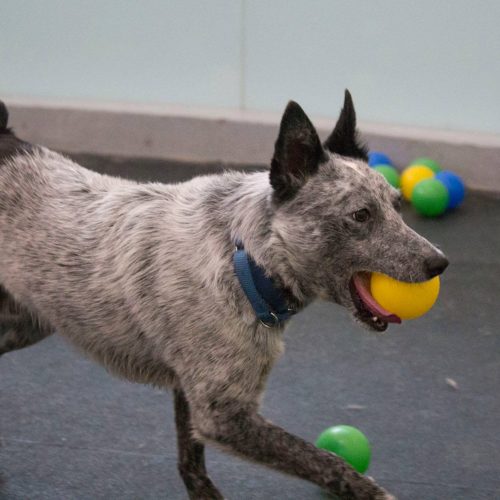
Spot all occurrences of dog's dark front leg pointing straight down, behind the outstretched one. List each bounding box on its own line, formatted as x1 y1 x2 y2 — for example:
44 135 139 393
174 389 224 500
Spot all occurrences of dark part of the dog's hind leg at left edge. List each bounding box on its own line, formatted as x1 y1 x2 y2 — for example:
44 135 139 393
0 285 53 356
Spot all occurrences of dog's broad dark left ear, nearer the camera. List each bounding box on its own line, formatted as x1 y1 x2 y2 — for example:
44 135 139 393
270 101 325 200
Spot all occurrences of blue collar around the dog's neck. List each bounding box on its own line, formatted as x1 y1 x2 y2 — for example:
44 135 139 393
233 241 297 328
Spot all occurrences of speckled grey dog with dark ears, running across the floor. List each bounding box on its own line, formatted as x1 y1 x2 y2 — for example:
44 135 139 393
0 92 447 499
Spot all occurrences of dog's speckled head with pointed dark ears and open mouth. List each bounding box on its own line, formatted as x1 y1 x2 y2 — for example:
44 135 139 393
270 91 448 331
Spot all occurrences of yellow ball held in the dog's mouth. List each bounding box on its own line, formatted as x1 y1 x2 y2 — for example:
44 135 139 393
370 273 439 319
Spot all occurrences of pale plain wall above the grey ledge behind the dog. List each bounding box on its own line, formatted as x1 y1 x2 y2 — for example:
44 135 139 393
0 0 500 133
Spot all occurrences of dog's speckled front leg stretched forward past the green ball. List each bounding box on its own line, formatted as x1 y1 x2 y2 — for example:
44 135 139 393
189 400 394 500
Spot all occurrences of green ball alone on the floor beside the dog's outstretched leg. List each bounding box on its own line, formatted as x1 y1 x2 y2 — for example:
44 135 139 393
316 425 372 474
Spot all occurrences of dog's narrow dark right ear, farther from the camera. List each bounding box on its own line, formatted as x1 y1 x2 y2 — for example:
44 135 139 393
324 89 368 161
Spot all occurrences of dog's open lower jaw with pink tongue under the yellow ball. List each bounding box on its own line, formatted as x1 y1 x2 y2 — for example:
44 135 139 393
349 272 401 332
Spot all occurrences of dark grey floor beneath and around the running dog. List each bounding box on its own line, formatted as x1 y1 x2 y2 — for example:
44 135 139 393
0 157 500 500
